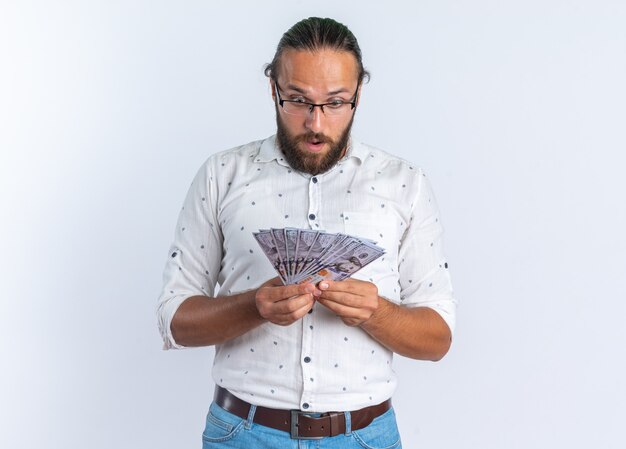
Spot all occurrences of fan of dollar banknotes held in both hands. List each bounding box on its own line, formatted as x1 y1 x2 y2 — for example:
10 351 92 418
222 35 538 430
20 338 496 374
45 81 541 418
253 228 385 285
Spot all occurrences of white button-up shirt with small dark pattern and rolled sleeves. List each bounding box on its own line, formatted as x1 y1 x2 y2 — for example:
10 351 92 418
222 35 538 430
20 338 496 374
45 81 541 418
157 136 456 412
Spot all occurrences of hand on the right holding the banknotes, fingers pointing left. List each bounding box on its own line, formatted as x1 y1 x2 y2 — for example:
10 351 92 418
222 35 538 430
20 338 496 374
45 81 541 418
317 279 379 326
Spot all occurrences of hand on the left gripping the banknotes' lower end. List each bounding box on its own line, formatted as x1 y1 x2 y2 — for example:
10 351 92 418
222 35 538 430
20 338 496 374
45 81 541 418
255 277 322 326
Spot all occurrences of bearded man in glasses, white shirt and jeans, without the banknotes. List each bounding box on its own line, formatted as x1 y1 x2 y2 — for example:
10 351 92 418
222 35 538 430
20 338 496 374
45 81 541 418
158 18 455 448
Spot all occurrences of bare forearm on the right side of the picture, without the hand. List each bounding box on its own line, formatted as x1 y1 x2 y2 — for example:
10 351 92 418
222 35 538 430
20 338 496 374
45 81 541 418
361 298 452 361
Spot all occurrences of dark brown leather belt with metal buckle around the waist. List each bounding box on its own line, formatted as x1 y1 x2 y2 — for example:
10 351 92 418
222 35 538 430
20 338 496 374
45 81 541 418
214 386 391 439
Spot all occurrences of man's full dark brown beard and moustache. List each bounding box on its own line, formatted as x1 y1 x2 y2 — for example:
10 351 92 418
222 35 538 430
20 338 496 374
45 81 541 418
276 108 354 175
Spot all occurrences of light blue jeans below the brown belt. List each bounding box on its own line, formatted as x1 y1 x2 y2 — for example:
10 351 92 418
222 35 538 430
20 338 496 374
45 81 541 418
202 403 402 449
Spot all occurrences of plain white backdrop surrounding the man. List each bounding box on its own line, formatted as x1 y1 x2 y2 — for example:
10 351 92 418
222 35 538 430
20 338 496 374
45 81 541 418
0 0 626 449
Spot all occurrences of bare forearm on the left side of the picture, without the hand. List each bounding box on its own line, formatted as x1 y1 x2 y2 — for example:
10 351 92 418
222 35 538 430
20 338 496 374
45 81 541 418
171 290 265 346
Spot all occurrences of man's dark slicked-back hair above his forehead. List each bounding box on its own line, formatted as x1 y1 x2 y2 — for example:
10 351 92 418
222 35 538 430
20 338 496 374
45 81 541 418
265 17 370 84
